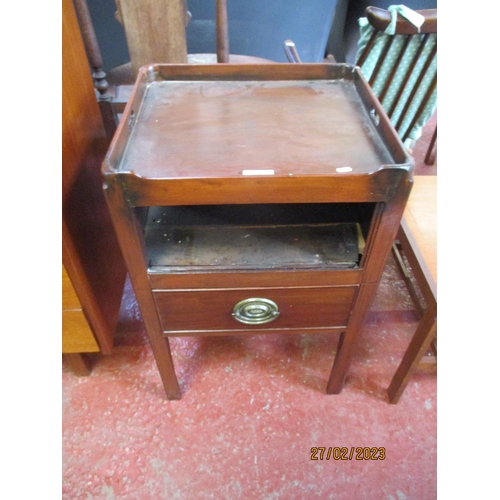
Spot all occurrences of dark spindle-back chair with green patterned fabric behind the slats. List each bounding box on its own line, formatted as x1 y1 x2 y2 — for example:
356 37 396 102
356 7 437 164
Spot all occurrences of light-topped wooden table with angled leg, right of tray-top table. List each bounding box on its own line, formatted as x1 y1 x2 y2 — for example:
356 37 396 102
388 176 437 404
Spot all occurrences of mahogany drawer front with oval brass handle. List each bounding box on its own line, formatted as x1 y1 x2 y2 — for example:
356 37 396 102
154 286 358 333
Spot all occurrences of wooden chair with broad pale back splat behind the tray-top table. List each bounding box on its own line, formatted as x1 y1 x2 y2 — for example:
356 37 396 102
74 0 272 140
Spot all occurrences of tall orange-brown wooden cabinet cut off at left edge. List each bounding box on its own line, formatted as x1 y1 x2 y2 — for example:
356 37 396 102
62 0 126 374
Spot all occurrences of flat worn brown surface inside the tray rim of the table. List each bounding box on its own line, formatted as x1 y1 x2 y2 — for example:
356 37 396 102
115 79 395 178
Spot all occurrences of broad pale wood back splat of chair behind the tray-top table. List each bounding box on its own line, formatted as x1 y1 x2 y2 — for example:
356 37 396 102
116 0 187 74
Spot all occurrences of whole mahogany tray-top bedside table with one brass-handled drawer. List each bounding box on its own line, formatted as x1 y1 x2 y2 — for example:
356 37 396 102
103 64 413 399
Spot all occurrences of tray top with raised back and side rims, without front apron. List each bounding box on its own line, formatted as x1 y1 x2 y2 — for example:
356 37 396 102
103 64 413 179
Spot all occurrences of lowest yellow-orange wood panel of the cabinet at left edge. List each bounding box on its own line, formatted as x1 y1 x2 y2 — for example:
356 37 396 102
62 309 99 354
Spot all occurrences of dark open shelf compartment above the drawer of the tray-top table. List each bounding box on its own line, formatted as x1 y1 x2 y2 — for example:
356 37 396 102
144 203 374 273
